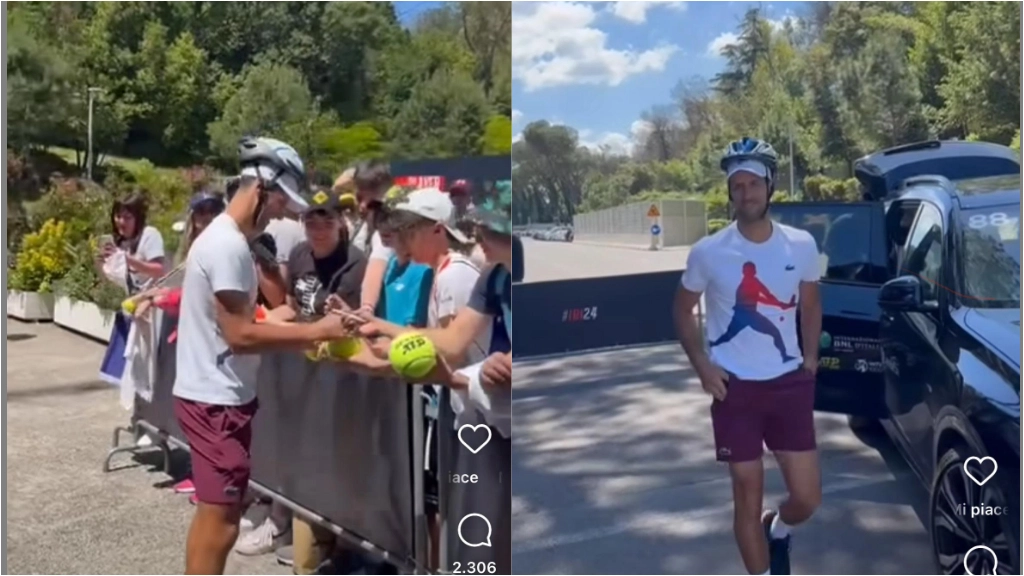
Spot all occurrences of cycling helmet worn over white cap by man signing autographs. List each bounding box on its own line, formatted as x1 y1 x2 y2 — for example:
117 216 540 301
239 137 308 212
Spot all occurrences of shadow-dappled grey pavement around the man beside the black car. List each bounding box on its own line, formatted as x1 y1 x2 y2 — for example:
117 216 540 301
512 342 934 574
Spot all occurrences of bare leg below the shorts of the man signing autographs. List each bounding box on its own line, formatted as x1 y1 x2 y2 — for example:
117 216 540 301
185 501 242 574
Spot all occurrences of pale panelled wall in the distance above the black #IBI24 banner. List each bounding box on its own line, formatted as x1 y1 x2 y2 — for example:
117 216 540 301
572 200 708 247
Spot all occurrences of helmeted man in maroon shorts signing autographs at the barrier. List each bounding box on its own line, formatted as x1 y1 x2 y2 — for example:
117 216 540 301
173 138 348 574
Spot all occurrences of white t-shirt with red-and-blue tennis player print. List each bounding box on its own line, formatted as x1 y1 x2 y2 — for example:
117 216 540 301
682 222 821 380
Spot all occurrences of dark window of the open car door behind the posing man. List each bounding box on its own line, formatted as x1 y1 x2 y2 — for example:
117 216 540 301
771 202 886 282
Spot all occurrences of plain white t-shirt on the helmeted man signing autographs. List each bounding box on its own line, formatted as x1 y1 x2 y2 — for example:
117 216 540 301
174 214 260 406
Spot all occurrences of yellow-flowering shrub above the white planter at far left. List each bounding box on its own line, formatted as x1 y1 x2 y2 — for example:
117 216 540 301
10 219 72 292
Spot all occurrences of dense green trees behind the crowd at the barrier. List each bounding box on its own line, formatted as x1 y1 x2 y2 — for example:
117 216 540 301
7 2 512 171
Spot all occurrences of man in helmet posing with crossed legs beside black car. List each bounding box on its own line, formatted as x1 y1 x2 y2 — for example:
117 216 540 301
675 138 821 574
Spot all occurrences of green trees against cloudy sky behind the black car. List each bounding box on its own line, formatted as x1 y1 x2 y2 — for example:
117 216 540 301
512 2 1021 223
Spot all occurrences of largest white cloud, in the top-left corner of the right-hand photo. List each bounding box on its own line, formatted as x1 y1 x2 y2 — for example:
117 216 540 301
512 2 678 91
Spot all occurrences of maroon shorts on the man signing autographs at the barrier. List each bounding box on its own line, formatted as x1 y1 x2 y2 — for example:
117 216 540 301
174 398 259 504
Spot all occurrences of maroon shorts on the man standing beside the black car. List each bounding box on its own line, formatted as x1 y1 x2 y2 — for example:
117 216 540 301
711 369 817 462
